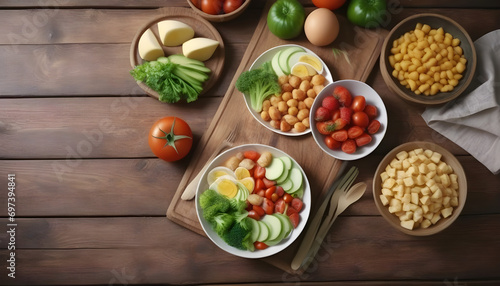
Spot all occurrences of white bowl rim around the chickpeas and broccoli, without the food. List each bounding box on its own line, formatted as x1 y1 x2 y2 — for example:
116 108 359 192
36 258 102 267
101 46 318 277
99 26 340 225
244 44 333 136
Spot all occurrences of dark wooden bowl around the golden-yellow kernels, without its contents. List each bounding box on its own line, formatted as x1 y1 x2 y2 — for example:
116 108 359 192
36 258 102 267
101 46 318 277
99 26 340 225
380 13 477 105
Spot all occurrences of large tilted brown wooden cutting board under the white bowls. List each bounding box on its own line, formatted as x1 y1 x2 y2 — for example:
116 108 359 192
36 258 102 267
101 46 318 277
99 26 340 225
167 1 388 273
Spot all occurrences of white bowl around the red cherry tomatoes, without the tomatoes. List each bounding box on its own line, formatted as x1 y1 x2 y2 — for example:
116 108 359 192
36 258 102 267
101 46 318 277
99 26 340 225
309 79 387 161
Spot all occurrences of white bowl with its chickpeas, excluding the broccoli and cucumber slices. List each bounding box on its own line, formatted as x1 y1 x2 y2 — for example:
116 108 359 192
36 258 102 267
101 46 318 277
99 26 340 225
243 44 333 136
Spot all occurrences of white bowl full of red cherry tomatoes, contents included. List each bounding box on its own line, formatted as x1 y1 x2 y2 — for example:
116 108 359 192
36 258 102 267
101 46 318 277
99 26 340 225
309 80 387 161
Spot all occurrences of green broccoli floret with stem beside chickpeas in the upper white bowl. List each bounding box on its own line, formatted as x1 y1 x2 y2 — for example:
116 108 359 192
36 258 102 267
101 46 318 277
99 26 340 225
236 68 281 112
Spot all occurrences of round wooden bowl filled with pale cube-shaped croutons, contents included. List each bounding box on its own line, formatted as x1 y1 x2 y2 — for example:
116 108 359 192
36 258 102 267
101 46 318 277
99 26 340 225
373 142 467 236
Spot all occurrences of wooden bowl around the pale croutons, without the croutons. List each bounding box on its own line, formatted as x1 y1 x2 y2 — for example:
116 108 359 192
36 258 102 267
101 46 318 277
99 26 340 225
373 142 467 236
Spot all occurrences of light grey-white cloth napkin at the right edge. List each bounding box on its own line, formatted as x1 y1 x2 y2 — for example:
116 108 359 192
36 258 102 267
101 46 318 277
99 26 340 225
422 30 500 174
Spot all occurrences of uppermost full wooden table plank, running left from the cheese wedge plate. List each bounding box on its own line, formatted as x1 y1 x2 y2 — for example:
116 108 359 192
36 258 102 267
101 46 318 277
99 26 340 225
0 8 260 45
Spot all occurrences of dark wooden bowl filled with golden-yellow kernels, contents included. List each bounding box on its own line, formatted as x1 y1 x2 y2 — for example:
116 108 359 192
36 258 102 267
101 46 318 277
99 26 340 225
380 13 477 105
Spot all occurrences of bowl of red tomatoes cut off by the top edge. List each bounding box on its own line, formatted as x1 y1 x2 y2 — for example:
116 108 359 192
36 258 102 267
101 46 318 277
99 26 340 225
187 0 250 22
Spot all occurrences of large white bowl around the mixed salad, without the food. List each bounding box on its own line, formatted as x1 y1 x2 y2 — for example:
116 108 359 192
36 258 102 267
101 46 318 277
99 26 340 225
195 144 311 258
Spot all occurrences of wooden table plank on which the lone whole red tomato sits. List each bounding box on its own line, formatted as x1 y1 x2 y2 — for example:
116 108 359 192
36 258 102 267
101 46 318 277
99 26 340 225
0 97 220 160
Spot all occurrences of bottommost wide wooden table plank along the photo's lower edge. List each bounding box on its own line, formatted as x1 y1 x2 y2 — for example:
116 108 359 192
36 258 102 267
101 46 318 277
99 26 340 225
0 215 500 285
